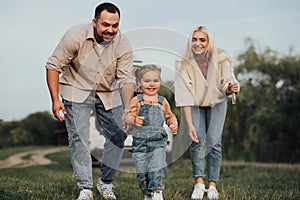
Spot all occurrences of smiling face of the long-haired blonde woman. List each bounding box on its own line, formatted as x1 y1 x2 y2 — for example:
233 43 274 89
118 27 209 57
192 31 208 55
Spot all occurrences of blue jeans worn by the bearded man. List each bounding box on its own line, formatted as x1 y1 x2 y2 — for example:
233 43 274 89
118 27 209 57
63 92 126 189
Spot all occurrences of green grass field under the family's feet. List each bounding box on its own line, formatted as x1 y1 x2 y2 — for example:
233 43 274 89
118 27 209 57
0 146 300 200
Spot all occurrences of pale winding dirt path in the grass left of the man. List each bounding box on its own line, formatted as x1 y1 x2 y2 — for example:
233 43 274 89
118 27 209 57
0 147 67 169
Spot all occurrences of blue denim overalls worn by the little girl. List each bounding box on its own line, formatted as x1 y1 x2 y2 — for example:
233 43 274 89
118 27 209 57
132 94 167 195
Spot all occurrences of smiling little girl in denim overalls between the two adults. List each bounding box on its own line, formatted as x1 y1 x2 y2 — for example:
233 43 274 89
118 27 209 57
125 65 178 200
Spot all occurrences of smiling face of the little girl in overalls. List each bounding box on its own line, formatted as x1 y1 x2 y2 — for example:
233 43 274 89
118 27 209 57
140 71 160 96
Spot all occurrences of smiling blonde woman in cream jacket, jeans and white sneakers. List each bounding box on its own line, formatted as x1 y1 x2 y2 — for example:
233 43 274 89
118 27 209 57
175 26 239 199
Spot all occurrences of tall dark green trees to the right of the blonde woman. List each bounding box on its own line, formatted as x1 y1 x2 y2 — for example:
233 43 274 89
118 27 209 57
223 39 300 163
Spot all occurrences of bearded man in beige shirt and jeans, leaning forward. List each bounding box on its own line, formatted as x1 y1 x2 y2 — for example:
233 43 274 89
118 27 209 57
46 3 135 200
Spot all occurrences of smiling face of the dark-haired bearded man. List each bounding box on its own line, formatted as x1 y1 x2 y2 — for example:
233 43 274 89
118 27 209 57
92 10 119 41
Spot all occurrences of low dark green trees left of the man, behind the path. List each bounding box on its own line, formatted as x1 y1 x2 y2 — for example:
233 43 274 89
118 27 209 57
0 111 66 149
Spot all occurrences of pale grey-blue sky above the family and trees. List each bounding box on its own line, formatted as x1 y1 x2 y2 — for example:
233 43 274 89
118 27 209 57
0 0 300 121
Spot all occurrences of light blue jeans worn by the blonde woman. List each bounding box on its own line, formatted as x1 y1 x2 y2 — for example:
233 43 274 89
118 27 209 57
190 100 227 182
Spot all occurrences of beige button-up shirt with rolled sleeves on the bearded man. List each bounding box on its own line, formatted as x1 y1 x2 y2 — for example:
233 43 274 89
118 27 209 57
46 24 135 109
